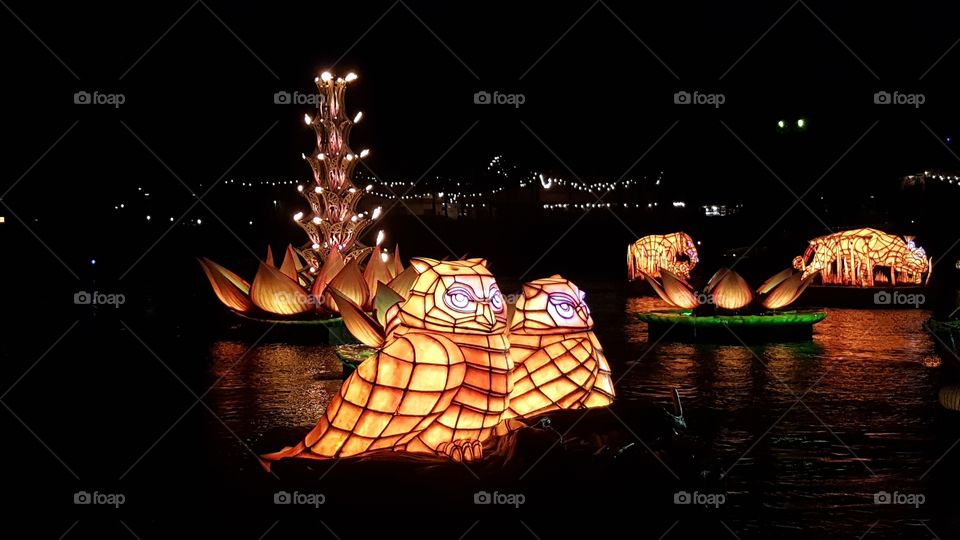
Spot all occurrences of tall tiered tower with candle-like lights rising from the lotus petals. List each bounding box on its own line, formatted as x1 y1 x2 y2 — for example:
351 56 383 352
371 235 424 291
293 71 380 269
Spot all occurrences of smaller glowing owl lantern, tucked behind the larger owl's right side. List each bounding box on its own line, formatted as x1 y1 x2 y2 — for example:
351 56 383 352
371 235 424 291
505 275 614 418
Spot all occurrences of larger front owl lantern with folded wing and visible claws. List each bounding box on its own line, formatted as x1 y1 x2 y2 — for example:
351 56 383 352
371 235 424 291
263 259 513 462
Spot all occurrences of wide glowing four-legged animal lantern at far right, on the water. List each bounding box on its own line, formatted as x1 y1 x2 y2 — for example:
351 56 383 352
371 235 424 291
793 229 933 287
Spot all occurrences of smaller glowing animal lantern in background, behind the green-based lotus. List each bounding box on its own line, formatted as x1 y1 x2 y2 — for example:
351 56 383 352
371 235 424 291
627 232 700 280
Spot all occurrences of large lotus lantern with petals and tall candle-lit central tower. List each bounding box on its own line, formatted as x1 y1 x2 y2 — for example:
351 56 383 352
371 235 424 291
200 72 403 318
